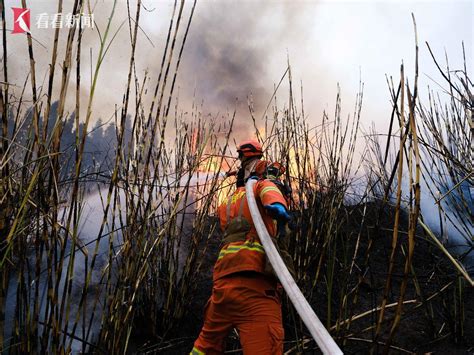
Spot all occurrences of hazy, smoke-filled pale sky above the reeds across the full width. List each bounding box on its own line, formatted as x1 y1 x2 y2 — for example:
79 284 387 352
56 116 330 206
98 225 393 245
2 0 474 140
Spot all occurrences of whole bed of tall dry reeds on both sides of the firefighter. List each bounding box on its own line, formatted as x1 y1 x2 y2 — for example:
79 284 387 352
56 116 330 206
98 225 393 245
0 0 473 354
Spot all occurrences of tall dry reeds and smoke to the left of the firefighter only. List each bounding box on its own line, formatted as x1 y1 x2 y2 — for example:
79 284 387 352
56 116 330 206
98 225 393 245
0 1 231 353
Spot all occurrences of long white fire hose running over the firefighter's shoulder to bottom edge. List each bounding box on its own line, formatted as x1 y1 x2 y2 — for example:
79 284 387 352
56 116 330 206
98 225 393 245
245 179 343 354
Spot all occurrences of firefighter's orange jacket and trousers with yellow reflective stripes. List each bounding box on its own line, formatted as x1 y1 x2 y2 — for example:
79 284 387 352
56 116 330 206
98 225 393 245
191 180 287 355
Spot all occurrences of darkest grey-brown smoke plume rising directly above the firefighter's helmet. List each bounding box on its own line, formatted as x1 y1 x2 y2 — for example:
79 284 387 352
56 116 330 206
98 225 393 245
180 3 271 131
